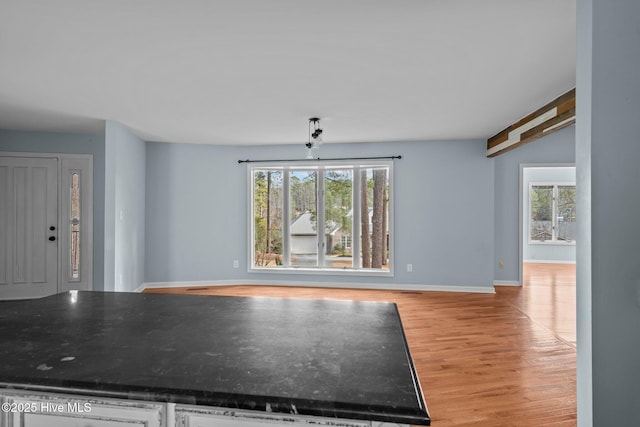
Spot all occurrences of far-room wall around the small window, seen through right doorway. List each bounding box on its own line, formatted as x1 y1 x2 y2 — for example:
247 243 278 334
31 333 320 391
522 167 577 262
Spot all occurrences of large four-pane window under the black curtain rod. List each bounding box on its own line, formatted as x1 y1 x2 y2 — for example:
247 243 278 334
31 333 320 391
249 162 393 275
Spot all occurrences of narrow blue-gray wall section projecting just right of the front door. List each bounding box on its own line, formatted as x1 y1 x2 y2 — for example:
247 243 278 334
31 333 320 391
104 120 146 291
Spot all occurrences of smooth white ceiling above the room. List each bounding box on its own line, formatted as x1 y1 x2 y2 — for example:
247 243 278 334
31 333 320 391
0 0 576 145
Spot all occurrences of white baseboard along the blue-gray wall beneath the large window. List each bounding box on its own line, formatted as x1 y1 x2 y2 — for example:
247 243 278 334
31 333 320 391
139 279 495 294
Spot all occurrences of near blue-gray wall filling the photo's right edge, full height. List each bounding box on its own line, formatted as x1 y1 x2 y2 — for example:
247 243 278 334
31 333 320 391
576 0 640 427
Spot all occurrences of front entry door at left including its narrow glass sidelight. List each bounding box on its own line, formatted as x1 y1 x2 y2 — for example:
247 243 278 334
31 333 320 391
0 153 93 299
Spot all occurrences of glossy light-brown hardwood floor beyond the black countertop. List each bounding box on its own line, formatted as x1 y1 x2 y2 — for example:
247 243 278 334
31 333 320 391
145 264 576 427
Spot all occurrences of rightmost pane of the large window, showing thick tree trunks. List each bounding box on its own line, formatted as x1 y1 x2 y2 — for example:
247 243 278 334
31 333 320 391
360 167 389 270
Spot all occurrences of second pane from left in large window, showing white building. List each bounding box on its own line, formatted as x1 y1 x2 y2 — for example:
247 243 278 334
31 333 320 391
289 170 318 267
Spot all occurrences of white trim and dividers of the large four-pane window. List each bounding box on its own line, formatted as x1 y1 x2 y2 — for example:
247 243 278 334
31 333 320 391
246 160 395 277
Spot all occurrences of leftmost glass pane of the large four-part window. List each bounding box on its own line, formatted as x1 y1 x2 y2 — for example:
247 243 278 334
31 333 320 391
253 170 283 267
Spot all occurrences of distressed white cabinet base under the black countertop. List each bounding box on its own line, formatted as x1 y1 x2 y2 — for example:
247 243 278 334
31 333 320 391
0 389 408 427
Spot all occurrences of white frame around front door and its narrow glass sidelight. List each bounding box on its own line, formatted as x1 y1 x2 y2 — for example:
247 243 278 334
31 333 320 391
0 151 93 292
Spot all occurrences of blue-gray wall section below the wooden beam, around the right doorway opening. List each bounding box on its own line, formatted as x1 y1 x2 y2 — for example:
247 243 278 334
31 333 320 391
491 126 575 282
